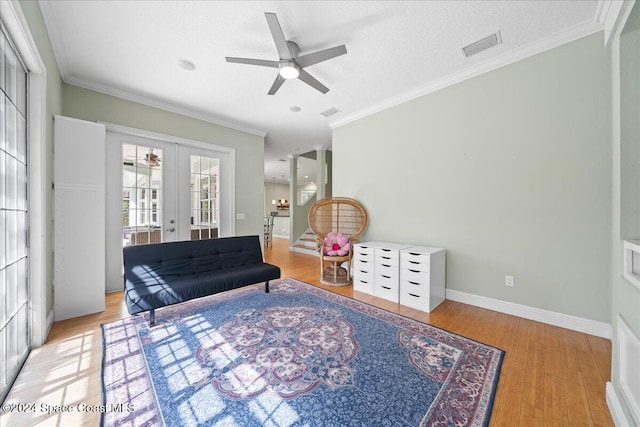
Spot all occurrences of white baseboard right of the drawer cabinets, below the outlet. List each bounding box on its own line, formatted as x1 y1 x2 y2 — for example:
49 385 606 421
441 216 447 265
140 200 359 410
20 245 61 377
446 289 612 339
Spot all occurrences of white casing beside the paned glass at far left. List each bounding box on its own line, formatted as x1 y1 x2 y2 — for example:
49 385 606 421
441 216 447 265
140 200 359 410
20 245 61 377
0 0 53 347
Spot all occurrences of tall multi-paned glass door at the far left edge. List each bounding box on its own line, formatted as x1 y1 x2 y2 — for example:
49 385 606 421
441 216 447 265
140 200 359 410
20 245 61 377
0 25 30 402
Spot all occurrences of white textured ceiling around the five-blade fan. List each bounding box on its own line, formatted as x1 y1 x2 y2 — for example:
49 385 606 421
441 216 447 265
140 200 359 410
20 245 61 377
39 0 609 182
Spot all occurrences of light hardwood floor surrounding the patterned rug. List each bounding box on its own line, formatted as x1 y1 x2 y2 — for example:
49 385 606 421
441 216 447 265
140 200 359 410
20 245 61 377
0 239 613 426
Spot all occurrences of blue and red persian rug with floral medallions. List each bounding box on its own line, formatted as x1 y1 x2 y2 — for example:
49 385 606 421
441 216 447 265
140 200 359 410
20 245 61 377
102 279 504 427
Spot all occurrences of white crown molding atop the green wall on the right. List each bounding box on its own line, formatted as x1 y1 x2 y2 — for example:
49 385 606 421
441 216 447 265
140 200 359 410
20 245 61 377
329 21 602 129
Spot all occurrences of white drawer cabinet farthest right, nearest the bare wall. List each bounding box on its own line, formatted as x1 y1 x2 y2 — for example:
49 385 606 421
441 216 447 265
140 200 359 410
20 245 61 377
400 246 445 312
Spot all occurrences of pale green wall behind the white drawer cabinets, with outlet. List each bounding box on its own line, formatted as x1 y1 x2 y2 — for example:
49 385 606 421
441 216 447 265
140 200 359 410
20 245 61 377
333 33 612 323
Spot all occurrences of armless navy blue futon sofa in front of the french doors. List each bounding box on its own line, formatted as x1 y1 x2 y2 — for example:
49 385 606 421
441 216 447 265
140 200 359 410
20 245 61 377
123 236 280 325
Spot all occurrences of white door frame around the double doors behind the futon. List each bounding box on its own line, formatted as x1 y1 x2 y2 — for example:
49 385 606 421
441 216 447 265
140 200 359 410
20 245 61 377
104 122 236 292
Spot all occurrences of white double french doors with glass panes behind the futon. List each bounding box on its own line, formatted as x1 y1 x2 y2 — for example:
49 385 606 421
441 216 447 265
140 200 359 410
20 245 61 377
106 126 235 291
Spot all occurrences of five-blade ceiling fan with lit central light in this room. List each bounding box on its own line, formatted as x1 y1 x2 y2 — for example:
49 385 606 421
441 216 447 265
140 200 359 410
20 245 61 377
226 12 347 95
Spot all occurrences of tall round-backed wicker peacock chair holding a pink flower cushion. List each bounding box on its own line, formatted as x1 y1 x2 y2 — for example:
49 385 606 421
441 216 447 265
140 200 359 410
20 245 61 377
309 197 369 285
